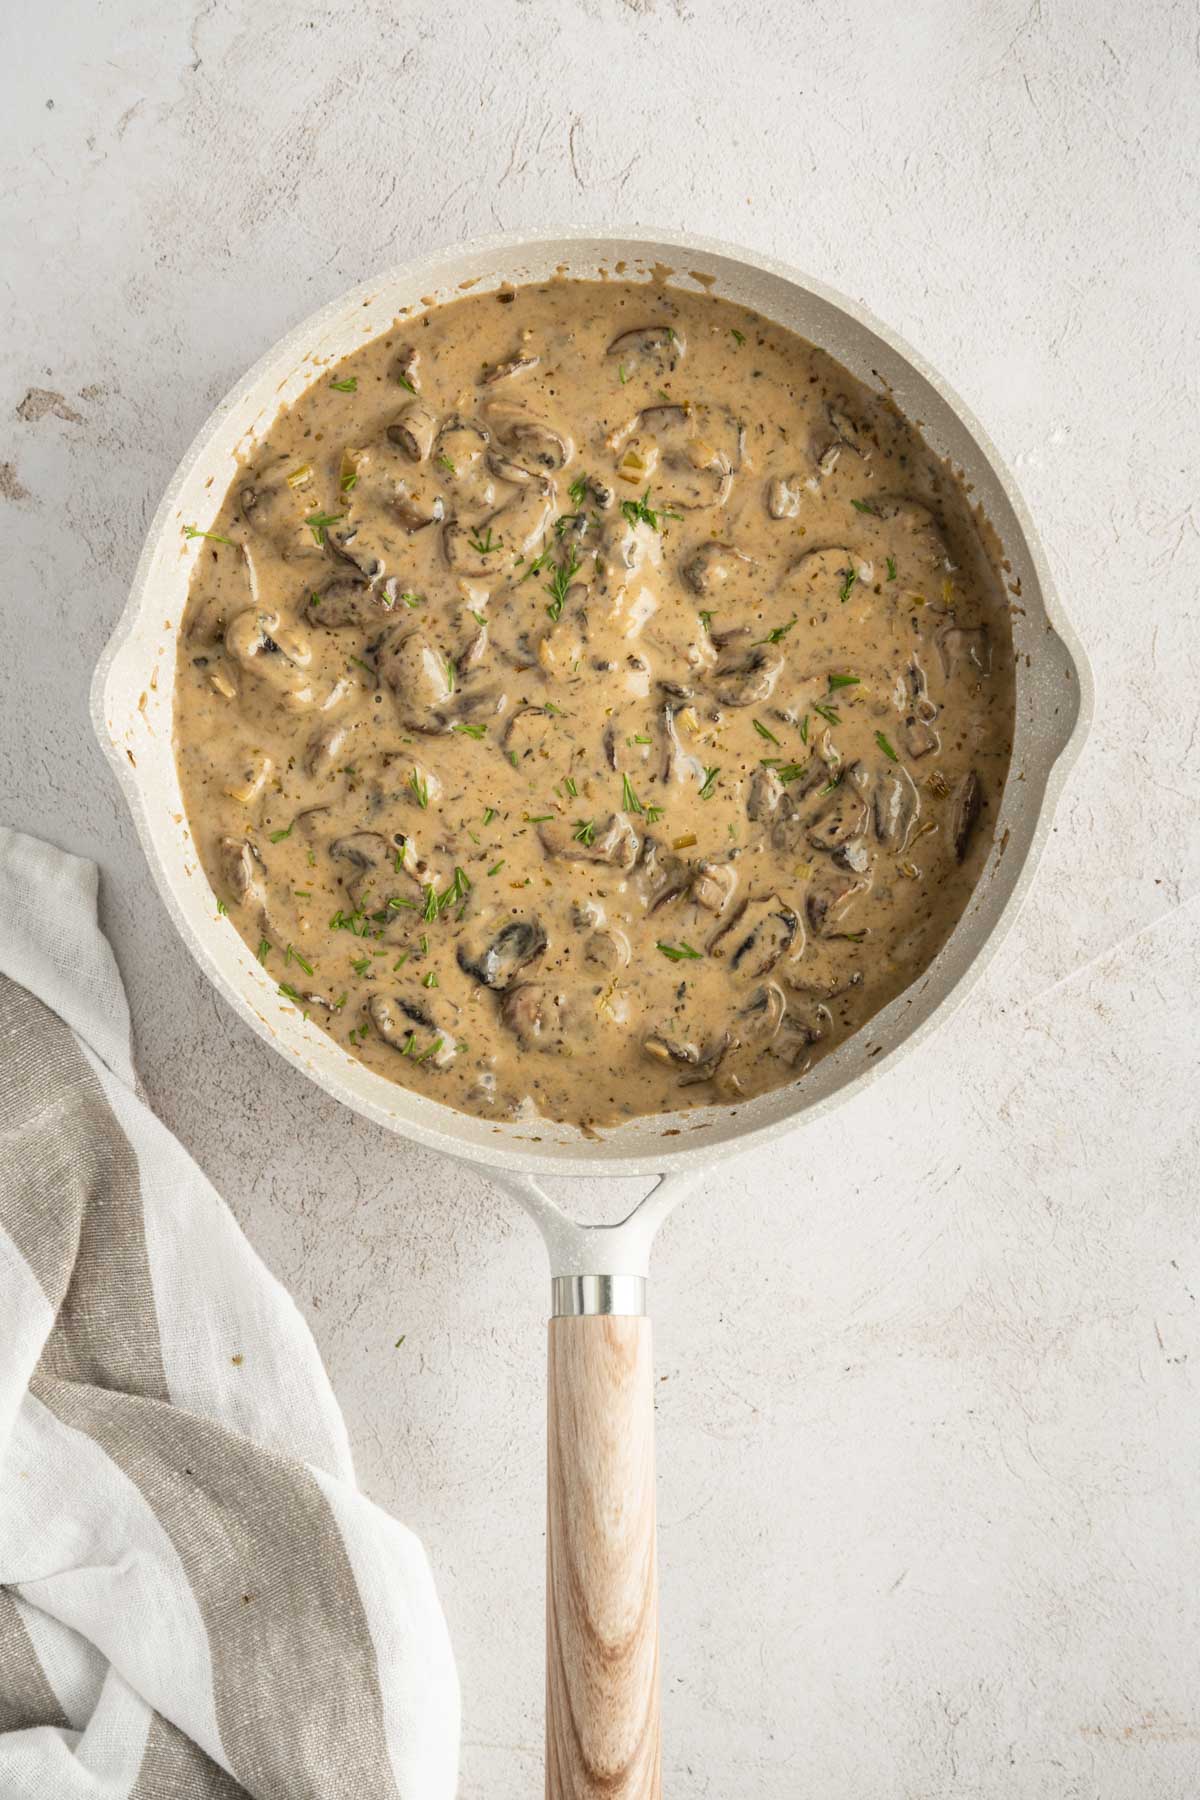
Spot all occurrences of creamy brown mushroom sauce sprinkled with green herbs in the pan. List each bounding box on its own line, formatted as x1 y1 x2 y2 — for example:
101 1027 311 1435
175 279 1013 1130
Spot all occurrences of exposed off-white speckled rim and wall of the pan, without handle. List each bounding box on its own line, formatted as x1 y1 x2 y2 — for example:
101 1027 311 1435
92 232 1092 1175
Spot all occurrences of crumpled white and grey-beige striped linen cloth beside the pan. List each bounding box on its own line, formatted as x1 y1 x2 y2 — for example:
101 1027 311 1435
0 828 459 1800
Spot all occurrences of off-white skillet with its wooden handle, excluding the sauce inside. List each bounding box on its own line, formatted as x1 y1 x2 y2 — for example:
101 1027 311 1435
92 230 1092 1800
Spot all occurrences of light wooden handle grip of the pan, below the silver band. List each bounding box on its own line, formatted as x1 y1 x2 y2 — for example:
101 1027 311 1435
545 1314 662 1800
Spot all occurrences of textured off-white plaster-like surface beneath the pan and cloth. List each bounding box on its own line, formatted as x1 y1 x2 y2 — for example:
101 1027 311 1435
0 0 1200 1800
